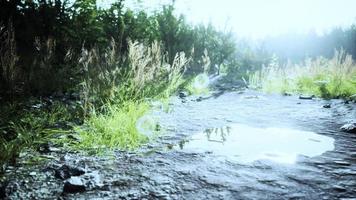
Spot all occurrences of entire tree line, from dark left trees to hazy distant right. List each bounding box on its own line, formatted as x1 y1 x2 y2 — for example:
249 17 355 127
0 0 356 95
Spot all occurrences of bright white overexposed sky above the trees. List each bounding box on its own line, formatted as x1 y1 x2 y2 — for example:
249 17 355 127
101 0 356 38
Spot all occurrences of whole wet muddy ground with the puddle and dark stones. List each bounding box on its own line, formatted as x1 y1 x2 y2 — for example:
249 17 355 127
0 91 356 199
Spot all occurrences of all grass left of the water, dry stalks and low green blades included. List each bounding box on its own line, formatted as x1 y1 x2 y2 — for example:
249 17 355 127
0 39 196 169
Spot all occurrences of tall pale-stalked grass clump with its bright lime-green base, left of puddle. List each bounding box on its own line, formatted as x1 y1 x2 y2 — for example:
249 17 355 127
75 41 190 152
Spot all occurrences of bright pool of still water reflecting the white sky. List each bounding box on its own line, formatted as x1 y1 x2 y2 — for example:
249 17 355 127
179 124 334 164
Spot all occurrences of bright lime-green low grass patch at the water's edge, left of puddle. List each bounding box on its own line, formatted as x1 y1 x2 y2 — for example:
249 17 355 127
75 102 149 152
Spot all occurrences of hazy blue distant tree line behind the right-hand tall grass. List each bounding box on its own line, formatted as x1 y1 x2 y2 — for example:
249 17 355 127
261 24 356 62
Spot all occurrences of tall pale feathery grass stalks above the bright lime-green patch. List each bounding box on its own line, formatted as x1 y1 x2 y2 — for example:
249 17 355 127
79 40 190 113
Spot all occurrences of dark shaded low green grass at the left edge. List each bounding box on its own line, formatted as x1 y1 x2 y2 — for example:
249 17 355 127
0 102 72 171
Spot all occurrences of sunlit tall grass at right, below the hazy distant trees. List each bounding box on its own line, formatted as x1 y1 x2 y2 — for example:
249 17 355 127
250 50 356 98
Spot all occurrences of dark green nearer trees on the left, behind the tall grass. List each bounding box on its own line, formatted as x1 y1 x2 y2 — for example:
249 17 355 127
0 0 236 95
